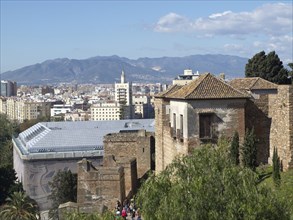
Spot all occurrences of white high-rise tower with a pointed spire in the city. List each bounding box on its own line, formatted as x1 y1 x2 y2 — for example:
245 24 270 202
115 70 133 119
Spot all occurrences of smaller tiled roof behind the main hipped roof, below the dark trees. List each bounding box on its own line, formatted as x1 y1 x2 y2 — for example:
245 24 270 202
229 77 278 91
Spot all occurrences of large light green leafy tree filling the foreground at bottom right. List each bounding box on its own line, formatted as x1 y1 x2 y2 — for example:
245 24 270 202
136 147 289 220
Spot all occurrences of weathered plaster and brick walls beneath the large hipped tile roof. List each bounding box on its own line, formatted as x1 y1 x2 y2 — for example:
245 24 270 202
155 99 246 172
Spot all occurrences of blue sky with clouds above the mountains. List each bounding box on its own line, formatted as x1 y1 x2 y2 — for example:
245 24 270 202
0 0 293 73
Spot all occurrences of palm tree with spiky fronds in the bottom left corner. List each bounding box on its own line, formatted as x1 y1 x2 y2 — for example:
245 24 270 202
0 192 40 220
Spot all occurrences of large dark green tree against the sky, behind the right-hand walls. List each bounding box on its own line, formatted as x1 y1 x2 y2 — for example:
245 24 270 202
245 51 290 84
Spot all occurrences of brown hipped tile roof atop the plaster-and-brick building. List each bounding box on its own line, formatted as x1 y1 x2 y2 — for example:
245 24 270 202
165 73 249 99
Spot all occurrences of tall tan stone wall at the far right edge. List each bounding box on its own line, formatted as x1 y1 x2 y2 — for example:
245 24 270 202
269 85 293 170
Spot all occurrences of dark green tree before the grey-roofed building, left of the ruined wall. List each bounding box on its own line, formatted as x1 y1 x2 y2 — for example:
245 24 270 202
49 170 77 219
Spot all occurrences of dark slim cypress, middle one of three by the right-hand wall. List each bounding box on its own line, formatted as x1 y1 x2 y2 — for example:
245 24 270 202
241 128 257 171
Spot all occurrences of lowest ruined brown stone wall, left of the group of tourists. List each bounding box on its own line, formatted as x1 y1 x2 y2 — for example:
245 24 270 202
77 159 125 213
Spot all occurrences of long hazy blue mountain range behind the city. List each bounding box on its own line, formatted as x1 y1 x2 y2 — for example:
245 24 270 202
2 54 248 85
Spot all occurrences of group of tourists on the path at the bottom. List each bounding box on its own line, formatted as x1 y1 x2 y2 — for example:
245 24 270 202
115 199 142 220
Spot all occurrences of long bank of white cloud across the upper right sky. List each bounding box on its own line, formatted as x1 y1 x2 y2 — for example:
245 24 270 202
154 3 293 36
